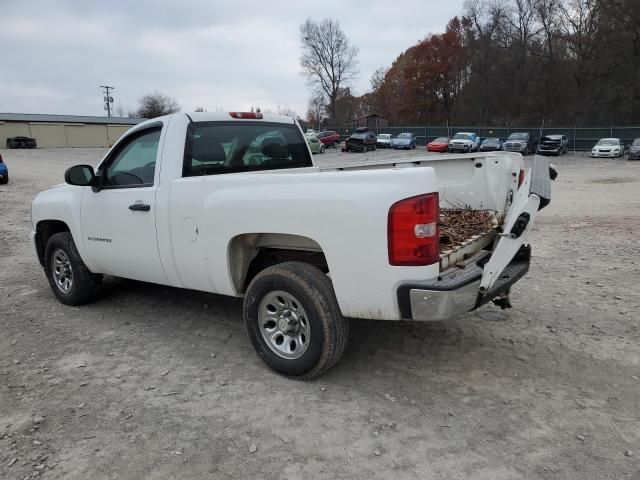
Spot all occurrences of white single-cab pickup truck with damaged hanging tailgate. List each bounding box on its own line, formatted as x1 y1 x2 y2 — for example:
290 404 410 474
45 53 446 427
32 112 555 378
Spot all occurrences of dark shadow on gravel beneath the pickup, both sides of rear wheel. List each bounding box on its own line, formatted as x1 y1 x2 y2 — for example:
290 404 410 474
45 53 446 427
89 277 490 372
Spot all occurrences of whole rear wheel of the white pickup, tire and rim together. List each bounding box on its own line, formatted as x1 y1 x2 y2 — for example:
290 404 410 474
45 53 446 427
244 262 349 379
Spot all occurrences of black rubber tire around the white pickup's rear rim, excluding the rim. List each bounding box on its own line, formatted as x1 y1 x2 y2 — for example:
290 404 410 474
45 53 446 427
243 262 349 379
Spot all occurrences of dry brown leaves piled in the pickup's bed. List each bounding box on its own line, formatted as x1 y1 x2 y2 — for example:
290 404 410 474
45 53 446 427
440 208 497 249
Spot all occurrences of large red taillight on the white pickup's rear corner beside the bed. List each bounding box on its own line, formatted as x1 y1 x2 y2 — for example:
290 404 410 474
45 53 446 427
387 193 440 266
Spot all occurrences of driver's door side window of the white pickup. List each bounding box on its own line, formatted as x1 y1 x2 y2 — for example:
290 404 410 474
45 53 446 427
105 128 161 188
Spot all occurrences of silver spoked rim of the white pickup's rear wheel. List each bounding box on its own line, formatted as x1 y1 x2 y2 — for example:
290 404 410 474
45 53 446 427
258 290 311 360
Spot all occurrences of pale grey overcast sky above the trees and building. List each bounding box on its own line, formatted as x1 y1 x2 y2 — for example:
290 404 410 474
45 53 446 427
0 0 463 116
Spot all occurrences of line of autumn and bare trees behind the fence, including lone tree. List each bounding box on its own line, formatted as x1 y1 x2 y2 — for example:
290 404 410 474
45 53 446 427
301 0 640 126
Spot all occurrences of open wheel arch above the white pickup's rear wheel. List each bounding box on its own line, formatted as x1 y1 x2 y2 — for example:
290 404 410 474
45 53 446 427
227 233 329 293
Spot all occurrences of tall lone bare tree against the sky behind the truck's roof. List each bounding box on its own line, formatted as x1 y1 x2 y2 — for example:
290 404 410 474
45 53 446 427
300 18 358 120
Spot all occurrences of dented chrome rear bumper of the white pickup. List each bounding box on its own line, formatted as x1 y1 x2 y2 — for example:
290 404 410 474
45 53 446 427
398 246 531 321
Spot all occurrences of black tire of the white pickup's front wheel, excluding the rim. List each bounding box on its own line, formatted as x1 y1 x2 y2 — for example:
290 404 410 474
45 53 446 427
44 232 102 305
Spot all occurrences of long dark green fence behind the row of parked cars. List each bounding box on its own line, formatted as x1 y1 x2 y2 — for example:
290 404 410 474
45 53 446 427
325 126 640 152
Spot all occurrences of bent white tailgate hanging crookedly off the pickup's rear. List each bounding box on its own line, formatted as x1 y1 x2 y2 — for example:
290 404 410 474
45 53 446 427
478 156 551 295
